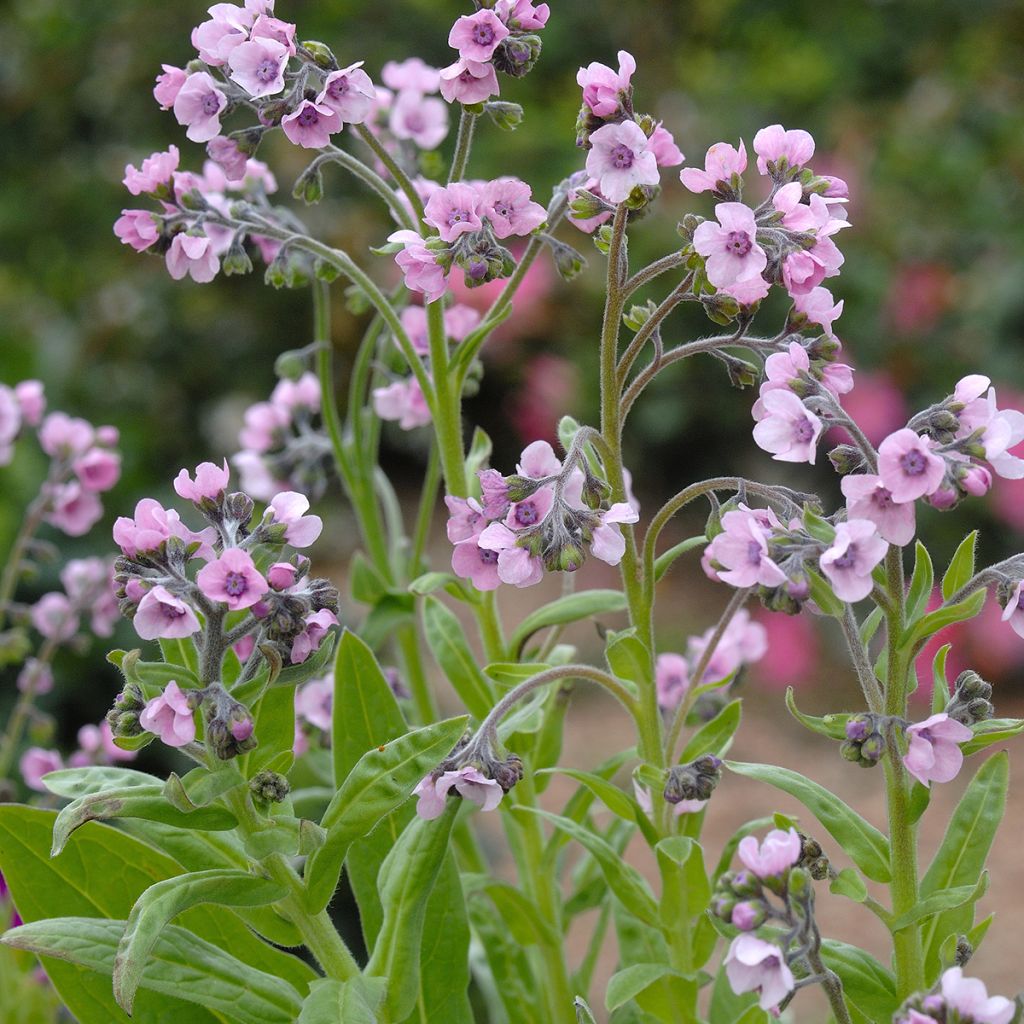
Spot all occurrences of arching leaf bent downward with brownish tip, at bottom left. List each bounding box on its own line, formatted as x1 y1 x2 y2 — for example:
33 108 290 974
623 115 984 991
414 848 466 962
114 870 287 1014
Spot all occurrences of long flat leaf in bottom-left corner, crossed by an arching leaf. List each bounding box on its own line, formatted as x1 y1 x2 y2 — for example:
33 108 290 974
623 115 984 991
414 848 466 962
0 918 302 1024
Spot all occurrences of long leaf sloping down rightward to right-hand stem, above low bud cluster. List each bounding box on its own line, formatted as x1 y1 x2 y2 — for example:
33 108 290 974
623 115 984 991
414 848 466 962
726 761 892 882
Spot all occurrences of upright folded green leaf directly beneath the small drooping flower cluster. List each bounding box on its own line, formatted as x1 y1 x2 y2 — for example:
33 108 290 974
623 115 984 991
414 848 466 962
366 800 460 1021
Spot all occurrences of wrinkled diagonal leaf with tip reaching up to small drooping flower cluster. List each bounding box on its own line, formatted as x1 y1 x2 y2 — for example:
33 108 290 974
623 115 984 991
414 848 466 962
305 717 467 913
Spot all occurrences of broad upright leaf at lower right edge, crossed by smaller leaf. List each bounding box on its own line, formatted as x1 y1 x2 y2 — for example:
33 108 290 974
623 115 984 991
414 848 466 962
921 752 1010 977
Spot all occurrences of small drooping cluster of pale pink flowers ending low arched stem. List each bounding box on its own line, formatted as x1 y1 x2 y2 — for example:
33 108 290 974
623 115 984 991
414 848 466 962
413 731 523 821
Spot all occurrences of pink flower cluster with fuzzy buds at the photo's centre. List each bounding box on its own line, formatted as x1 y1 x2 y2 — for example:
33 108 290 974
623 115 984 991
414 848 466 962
444 441 638 590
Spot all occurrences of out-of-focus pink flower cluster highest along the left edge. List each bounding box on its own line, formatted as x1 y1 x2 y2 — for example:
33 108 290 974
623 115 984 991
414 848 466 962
0 380 121 537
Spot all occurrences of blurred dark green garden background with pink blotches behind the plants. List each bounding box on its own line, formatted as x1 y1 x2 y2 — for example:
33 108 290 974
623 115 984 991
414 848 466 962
0 0 1024 994
